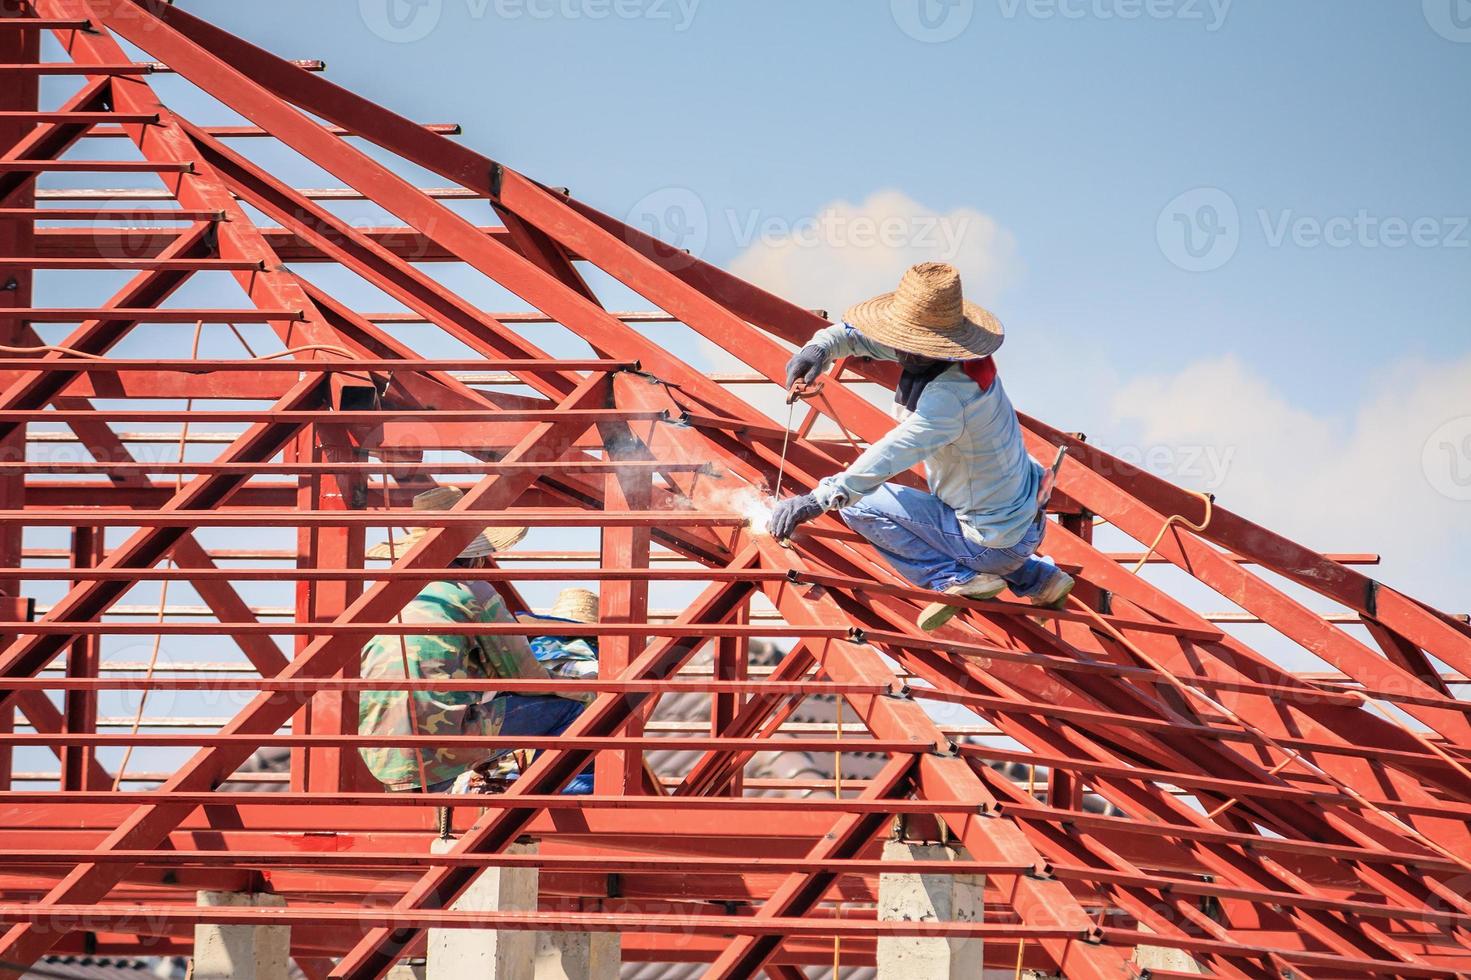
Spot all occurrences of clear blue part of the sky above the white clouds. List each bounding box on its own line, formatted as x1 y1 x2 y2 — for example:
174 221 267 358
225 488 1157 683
192 0 1471 400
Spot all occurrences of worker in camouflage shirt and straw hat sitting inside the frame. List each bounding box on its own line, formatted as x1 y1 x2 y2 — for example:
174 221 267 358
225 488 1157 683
357 487 584 793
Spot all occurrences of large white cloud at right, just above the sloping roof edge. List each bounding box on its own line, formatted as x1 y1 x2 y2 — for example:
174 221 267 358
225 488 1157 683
1109 351 1471 612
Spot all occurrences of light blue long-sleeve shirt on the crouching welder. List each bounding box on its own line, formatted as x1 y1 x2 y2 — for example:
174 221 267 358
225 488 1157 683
808 324 1043 547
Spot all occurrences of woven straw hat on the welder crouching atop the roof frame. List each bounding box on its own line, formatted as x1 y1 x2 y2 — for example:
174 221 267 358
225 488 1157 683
843 262 1003 361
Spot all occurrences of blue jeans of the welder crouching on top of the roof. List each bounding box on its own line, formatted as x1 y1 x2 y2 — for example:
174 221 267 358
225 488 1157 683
840 483 1061 596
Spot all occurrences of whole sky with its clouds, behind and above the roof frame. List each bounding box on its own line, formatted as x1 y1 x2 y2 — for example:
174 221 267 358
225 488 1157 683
14 0 1471 776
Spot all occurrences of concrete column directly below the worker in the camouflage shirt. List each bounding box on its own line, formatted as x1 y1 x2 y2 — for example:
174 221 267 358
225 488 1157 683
428 840 538 980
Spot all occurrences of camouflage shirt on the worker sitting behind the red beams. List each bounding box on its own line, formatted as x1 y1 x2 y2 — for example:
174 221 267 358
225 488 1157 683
357 581 547 790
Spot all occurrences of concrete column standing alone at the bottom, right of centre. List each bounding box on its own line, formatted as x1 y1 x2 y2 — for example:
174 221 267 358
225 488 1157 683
878 840 986 980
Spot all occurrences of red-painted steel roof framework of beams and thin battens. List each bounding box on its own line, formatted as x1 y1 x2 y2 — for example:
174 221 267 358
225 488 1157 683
0 0 1471 980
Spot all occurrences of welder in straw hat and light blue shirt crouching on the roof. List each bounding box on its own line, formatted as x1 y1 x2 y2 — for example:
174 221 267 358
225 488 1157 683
771 262 1072 630
